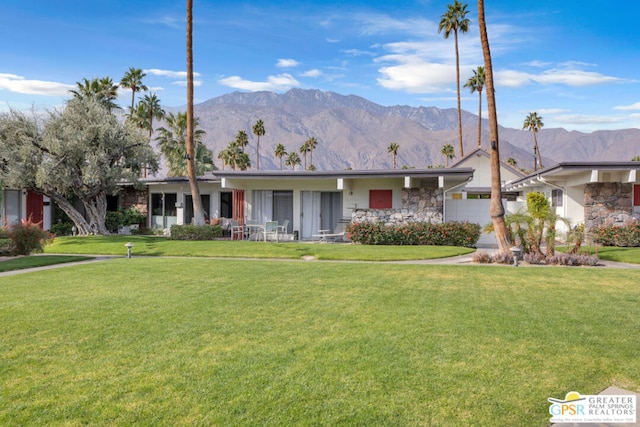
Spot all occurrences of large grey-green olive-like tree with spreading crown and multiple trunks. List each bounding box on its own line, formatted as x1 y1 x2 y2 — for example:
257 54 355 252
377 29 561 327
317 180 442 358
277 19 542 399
0 97 158 235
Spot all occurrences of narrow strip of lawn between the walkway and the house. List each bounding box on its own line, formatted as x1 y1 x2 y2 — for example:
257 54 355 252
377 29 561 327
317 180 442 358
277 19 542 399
45 236 474 261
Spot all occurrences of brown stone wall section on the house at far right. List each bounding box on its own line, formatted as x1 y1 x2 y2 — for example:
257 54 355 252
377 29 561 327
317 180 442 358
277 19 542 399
584 182 639 230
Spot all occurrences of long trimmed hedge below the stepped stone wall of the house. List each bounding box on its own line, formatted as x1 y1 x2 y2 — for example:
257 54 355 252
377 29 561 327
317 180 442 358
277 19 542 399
345 222 481 247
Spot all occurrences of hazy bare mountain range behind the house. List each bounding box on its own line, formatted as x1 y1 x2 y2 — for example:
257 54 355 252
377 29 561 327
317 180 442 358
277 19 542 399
186 89 640 170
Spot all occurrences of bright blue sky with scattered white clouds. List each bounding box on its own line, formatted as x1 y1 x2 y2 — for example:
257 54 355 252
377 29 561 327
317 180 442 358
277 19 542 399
0 0 640 132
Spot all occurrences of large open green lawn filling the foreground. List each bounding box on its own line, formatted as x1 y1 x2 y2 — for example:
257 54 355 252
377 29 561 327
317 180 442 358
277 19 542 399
0 260 640 426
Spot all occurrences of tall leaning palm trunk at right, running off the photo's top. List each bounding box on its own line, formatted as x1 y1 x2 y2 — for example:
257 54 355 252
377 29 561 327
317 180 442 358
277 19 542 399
478 0 511 254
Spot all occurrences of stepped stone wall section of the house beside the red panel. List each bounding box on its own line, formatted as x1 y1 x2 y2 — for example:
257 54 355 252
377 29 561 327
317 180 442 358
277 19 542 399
351 187 444 225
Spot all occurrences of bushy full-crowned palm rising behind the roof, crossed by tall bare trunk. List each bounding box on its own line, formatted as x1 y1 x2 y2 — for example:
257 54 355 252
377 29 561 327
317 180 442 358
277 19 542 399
156 113 215 176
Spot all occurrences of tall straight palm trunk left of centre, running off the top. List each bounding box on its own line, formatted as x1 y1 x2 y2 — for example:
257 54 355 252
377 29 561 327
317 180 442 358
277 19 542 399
186 0 204 226
